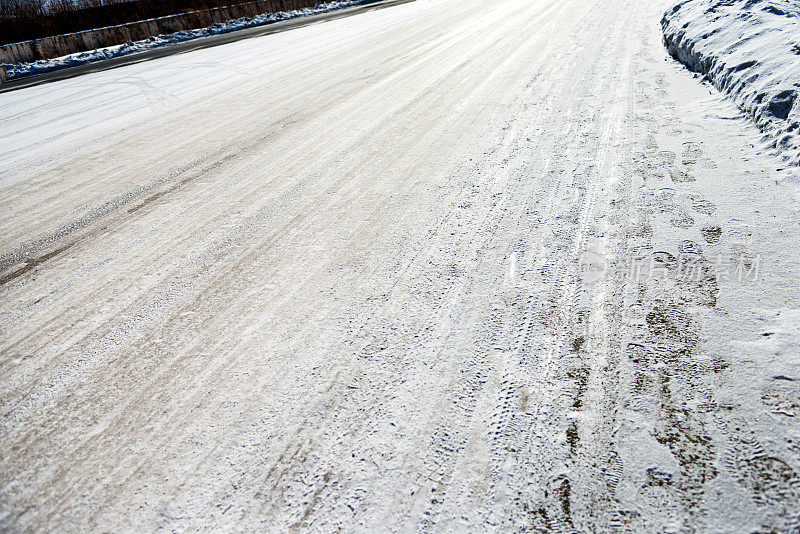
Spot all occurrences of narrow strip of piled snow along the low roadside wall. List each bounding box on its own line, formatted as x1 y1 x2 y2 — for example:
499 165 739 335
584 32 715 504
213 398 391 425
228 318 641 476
6 0 368 80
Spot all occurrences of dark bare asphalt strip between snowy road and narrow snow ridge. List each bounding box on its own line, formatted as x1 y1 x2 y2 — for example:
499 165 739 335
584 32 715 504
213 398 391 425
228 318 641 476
0 0 413 94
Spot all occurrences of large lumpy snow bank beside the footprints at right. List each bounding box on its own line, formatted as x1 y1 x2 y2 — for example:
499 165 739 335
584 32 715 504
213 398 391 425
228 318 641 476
661 0 800 165
